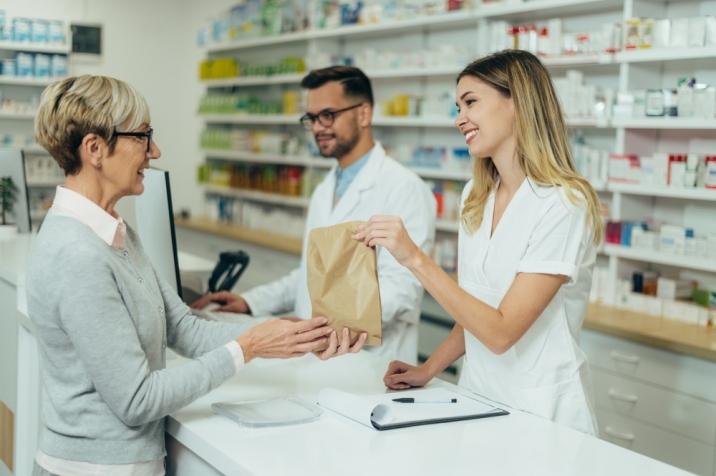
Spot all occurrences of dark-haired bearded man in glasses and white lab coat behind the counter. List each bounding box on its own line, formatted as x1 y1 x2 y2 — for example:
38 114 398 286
192 66 436 363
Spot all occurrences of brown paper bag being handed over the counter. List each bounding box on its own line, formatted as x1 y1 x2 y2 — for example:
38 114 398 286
307 221 383 350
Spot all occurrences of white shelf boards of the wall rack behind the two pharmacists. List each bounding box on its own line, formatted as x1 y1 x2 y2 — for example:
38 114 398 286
194 0 716 303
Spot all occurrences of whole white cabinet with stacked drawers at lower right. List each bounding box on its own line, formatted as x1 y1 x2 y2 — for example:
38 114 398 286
581 330 716 475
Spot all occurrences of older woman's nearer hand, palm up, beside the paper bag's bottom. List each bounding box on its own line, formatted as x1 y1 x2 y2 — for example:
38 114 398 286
236 317 333 363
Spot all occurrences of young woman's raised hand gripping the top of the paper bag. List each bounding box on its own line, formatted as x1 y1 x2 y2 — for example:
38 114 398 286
353 215 422 266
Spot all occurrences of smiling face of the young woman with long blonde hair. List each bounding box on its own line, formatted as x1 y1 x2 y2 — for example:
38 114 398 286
455 76 516 159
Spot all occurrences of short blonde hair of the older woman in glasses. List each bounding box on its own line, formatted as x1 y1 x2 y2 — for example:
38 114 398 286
35 74 151 175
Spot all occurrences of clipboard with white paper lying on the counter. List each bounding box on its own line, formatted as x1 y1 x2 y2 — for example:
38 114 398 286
318 387 509 431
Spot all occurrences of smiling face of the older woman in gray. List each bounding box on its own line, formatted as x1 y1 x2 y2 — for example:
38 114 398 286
102 124 162 197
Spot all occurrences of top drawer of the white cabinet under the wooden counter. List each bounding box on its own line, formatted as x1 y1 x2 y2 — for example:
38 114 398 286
581 330 716 403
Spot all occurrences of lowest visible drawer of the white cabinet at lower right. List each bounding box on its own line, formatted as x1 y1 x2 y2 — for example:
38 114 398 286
596 406 714 476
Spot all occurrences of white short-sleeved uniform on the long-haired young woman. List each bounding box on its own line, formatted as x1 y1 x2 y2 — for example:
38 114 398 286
458 179 598 435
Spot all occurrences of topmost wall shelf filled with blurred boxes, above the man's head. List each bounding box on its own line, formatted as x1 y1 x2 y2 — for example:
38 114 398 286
198 0 623 55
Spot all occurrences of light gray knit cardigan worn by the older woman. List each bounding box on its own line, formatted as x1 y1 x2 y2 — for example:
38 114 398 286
27 213 252 464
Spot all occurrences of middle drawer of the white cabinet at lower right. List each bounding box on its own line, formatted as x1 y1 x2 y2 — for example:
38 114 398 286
592 369 716 445
